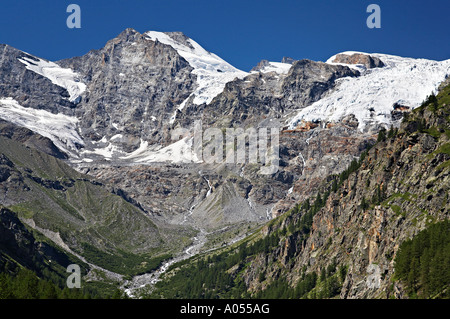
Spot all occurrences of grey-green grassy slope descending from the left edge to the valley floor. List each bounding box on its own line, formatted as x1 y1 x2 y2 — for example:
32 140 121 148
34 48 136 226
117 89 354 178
0 137 167 274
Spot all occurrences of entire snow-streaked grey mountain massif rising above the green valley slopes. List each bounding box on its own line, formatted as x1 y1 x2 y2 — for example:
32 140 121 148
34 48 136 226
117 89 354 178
0 29 450 231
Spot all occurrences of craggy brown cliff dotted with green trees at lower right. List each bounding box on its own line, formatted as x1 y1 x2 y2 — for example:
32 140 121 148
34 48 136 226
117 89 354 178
237 86 450 298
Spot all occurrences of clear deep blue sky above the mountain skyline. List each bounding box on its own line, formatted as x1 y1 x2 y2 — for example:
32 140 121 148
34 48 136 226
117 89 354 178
0 0 450 71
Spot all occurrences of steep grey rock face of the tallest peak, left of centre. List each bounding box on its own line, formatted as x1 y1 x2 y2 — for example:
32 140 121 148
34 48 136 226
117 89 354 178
58 29 195 152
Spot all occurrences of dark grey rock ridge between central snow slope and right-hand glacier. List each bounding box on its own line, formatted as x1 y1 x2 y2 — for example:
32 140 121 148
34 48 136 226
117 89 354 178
188 60 359 127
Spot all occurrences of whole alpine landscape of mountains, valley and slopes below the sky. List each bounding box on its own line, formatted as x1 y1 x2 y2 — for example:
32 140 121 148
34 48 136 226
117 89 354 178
0 29 450 298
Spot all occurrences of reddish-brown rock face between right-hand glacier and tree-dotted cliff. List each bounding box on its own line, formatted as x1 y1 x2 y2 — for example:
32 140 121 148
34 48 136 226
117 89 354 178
271 119 375 217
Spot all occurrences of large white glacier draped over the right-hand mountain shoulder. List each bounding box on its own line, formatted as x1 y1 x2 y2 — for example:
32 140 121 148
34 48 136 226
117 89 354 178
288 51 450 131
